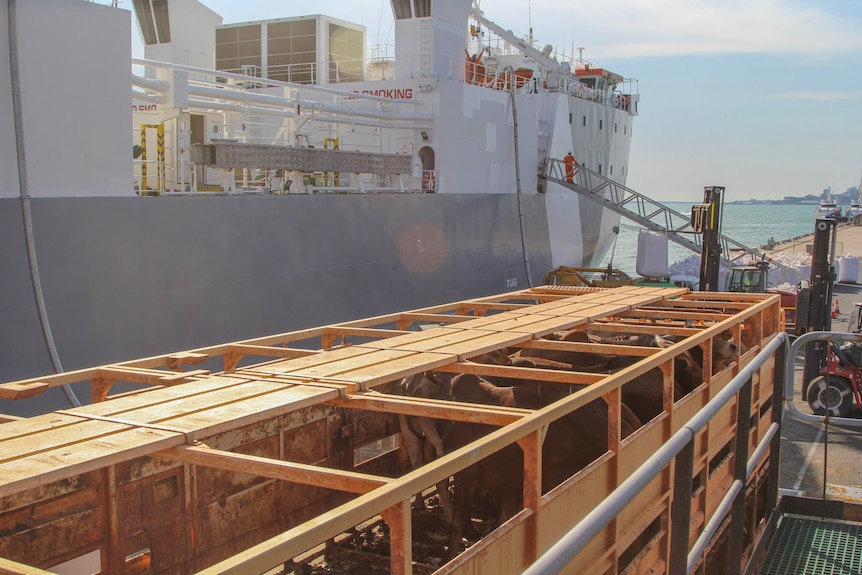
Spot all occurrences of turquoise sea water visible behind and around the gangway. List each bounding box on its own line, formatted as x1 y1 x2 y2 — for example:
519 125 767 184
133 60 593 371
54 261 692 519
602 202 828 276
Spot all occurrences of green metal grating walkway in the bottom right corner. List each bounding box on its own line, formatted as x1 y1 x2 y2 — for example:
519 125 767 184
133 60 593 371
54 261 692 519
758 515 862 575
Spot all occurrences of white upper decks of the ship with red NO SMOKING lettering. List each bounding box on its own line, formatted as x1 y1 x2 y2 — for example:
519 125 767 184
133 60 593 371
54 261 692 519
135 0 638 265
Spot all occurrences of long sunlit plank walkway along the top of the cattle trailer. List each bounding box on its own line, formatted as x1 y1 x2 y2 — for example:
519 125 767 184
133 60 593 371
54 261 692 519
0 286 784 497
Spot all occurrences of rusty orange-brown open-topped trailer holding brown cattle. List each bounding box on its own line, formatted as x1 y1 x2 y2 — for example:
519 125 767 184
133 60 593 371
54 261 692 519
0 286 860 574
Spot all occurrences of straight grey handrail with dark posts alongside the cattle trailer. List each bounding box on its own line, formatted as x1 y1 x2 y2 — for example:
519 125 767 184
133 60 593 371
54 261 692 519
524 333 788 575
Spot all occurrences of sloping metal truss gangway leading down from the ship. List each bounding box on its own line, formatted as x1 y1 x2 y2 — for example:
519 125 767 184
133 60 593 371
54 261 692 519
539 158 808 280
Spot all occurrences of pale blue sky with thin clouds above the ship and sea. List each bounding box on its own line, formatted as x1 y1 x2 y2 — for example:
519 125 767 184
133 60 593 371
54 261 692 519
128 0 862 202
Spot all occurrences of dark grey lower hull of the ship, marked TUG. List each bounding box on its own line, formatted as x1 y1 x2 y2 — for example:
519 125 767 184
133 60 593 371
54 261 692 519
0 193 601 414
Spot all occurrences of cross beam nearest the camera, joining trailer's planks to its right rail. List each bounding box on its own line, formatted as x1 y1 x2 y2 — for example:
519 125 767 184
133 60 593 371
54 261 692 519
159 445 390 493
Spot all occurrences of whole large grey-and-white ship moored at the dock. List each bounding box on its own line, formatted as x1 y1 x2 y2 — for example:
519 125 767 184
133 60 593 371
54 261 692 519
0 0 639 415
